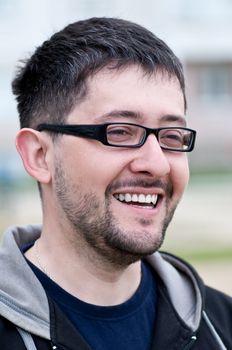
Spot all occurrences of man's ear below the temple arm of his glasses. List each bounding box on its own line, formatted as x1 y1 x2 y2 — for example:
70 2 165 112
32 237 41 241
16 128 51 184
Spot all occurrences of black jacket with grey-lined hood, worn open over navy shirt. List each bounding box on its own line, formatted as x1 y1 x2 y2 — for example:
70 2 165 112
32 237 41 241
0 225 232 350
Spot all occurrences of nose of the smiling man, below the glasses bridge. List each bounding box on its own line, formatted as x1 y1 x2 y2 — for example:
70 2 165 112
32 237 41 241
130 134 170 178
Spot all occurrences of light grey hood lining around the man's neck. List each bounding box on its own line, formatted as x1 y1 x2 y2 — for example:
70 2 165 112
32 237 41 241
0 225 202 339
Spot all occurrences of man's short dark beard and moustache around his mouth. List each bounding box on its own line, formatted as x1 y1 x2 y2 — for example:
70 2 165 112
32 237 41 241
54 161 177 267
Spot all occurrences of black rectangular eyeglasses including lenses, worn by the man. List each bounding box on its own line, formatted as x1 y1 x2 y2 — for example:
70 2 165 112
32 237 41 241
37 123 196 152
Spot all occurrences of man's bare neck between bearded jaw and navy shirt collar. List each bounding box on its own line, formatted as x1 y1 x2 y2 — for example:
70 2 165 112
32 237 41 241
25 234 141 306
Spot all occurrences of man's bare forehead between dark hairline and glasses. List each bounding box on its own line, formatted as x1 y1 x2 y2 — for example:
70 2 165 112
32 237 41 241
68 65 184 125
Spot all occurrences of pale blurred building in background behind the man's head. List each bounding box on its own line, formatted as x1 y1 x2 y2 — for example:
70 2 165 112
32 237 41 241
0 0 232 180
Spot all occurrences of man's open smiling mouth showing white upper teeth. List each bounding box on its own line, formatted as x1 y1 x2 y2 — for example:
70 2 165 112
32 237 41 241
114 193 160 209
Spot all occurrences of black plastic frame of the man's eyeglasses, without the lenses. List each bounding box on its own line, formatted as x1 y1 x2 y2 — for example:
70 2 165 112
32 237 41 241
36 122 197 152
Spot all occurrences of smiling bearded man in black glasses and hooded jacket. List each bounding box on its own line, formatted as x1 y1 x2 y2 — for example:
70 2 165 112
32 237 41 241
0 18 232 350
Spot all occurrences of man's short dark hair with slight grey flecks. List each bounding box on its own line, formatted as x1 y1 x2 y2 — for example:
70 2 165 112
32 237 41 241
12 18 186 128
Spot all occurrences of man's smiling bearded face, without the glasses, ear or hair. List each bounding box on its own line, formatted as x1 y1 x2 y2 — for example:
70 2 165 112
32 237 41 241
54 66 189 264
